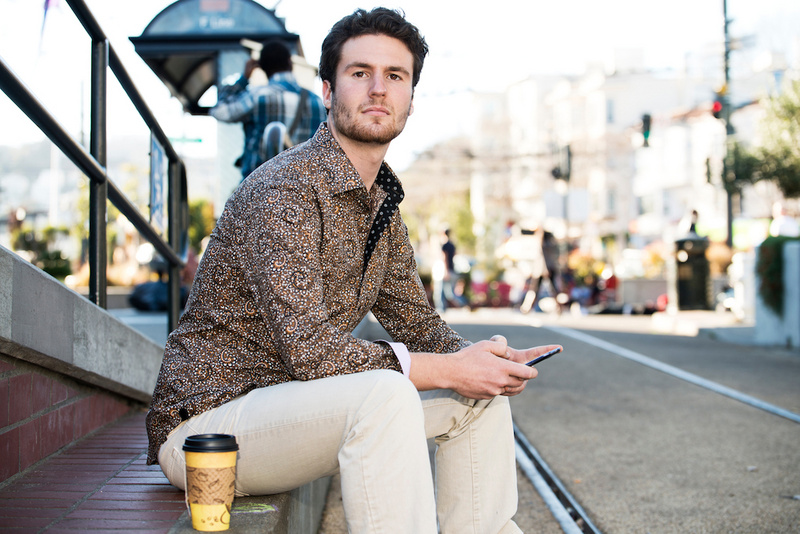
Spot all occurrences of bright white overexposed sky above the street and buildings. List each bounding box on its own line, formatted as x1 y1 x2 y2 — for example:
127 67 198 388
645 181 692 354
0 0 800 168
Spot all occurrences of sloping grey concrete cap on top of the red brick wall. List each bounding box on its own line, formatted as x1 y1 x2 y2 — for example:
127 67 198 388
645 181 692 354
0 247 164 404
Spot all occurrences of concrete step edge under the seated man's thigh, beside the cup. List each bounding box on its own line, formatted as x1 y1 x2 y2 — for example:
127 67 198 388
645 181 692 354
169 477 331 534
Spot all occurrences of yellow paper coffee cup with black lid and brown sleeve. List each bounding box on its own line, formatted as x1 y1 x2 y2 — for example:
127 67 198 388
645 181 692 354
183 434 239 532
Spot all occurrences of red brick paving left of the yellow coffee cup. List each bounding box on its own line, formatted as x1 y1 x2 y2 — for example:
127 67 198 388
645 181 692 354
0 413 186 534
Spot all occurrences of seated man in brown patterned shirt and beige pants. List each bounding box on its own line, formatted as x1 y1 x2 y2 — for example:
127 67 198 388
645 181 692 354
147 8 552 534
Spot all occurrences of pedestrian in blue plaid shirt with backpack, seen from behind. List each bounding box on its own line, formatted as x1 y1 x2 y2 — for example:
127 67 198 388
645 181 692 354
209 40 327 179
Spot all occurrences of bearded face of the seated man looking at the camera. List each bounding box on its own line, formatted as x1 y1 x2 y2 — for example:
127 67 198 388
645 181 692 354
322 35 414 145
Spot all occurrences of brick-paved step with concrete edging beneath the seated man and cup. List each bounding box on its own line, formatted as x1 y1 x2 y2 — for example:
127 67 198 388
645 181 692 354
0 412 330 534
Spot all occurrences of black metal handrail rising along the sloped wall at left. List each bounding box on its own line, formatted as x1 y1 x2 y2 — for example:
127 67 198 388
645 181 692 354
0 0 188 331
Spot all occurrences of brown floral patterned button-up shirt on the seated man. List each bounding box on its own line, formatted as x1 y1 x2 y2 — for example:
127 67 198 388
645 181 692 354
147 124 469 464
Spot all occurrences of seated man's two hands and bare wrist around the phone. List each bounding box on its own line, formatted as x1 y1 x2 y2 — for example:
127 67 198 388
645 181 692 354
410 336 557 399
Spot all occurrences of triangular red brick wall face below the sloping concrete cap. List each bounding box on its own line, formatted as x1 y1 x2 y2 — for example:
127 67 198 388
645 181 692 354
0 354 133 484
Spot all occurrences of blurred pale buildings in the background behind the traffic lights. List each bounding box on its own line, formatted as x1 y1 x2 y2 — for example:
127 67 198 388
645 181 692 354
416 48 796 280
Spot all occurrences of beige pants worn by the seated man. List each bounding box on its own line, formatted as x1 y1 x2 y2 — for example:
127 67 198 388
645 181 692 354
158 371 520 534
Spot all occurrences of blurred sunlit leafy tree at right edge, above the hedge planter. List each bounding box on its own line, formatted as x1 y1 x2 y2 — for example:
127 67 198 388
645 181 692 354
759 80 800 198
